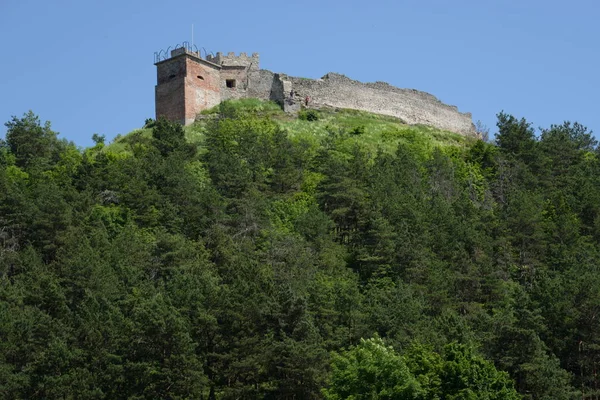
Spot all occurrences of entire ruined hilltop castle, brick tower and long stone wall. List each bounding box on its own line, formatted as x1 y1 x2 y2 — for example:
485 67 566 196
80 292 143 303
155 46 477 136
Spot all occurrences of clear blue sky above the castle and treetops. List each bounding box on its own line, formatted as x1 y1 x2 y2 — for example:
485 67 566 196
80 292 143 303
0 0 600 146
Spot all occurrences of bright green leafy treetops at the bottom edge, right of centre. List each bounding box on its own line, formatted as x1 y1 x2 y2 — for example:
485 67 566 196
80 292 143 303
323 338 521 400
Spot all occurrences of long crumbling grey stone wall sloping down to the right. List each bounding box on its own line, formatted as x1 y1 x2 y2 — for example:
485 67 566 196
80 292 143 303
283 73 476 136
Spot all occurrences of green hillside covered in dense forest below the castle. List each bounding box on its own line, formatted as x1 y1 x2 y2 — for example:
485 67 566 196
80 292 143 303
0 101 600 400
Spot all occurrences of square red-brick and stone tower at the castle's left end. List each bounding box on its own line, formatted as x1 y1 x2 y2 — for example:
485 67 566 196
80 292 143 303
155 47 221 125
